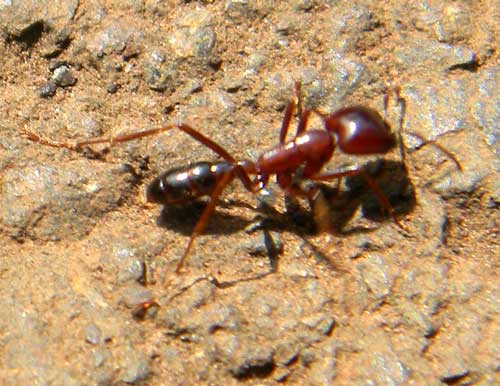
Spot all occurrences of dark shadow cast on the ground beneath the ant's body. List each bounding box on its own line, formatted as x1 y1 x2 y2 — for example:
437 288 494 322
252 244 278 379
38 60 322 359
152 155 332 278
157 159 416 240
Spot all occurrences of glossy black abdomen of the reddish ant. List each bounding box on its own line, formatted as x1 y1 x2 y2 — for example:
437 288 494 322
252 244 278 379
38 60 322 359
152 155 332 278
146 161 232 205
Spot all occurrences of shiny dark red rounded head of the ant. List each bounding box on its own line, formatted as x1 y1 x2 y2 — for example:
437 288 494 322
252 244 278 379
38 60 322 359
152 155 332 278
323 106 396 155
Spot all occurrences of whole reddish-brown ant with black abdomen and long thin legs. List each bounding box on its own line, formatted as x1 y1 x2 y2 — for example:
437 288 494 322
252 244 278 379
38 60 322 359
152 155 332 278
23 82 460 272
